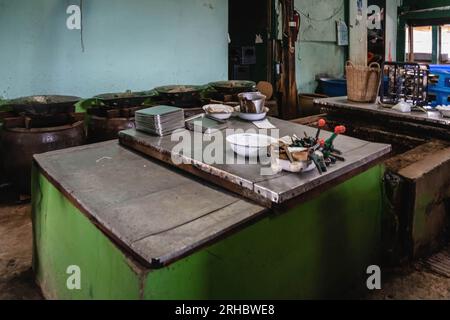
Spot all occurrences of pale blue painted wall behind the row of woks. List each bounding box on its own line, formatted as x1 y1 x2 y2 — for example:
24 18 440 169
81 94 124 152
0 0 228 98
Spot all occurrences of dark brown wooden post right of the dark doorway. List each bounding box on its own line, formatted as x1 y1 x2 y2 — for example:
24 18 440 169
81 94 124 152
279 0 298 120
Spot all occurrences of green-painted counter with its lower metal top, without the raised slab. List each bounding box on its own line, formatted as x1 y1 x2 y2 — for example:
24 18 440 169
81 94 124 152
33 141 383 299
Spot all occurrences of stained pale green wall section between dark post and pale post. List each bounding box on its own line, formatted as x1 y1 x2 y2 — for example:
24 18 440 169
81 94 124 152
295 0 347 93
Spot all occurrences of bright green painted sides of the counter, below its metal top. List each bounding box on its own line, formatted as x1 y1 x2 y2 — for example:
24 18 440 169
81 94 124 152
33 162 383 300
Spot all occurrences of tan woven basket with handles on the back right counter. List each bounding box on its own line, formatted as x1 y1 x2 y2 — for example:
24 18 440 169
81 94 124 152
345 61 381 102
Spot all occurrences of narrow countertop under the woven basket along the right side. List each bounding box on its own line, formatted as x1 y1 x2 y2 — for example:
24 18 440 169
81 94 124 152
314 97 450 128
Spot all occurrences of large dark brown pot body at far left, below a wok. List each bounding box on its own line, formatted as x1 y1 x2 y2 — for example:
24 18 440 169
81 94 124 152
1 121 85 194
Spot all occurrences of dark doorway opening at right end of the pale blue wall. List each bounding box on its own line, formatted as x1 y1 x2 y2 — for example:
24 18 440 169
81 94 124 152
228 0 273 83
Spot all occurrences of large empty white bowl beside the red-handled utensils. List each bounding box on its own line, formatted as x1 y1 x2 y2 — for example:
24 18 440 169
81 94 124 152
227 133 277 158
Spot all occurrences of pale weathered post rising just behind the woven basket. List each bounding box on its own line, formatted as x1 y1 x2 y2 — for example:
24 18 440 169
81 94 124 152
349 0 368 66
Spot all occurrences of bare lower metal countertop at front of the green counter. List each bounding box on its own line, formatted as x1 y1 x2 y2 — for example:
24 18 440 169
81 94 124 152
35 140 266 268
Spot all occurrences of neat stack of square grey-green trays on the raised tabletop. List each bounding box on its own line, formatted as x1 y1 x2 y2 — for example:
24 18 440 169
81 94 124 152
135 106 185 136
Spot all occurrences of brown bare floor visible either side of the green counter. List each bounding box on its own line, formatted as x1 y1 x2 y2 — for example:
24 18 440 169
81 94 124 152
0 204 450 300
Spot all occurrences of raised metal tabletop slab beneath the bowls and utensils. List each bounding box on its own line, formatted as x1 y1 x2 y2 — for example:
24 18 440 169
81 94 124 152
119 118 391 206
